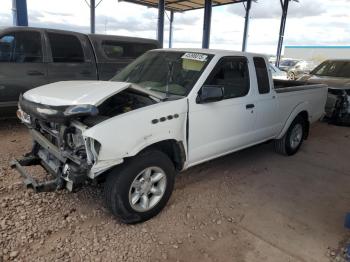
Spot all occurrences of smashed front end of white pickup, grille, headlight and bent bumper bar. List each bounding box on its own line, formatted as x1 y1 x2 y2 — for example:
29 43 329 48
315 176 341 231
12 95 100 191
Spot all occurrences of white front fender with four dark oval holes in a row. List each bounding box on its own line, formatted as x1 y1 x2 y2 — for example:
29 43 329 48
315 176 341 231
83 98 187 175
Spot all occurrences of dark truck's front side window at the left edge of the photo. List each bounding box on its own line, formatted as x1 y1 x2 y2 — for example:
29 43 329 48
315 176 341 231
0 31 43 63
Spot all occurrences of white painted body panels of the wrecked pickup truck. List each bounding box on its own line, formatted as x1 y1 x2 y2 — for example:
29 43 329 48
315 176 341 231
25 49 327 178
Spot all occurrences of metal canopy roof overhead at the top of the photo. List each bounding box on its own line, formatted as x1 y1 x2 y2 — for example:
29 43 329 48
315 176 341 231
119 0 247 12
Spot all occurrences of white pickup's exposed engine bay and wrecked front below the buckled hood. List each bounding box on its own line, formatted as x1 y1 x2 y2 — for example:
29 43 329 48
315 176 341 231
12 89 159 191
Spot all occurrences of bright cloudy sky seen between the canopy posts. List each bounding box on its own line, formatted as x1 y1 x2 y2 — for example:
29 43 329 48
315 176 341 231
0 0 350 54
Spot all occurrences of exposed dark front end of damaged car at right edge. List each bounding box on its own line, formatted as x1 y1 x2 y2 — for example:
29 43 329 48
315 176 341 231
326 88 350 125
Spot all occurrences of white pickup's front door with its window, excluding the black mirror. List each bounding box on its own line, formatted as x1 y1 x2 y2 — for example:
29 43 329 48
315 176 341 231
188 57 256 165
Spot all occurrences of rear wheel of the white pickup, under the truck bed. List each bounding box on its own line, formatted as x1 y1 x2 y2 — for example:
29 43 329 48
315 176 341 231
275 116 306 156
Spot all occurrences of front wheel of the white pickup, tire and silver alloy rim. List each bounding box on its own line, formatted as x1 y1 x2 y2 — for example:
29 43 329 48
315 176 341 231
105 150 176 224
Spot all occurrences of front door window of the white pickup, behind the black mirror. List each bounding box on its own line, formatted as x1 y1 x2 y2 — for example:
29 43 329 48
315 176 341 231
205 57 249 99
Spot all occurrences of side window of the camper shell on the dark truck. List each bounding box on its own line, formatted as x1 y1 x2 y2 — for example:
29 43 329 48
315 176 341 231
102 40 157 59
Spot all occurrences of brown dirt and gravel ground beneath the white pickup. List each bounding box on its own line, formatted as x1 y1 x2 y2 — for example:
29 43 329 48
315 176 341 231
0 121 350 262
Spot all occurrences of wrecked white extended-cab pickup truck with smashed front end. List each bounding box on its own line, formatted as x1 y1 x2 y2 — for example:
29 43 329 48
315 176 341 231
12 49 327 223
